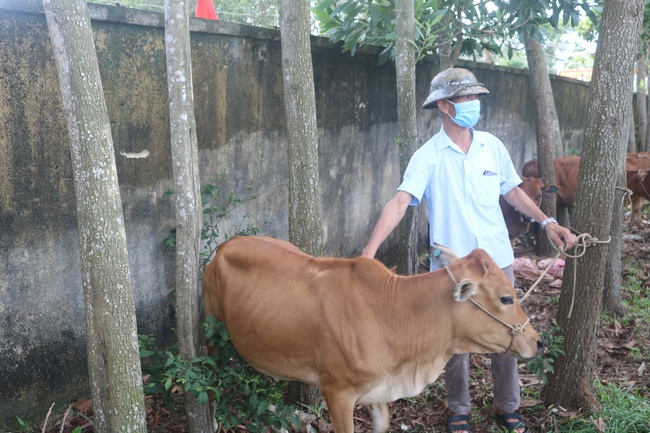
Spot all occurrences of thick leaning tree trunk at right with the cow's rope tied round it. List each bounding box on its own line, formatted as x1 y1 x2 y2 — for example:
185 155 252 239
542 0 643 409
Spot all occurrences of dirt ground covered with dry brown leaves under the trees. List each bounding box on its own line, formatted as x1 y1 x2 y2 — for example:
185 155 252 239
47 215 650 433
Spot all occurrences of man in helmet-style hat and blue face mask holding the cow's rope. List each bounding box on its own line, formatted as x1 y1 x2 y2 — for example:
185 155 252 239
361 68 577 433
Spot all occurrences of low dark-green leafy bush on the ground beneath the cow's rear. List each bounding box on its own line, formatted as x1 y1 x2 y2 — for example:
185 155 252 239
140 318 298 432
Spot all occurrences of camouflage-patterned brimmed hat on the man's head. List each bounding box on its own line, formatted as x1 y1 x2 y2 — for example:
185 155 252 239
422 68 490 108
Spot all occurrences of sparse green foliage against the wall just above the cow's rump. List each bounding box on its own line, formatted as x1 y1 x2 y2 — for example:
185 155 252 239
165 175 270 275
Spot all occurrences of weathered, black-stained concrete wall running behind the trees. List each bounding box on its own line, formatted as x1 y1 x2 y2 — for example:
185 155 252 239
0 0 588 430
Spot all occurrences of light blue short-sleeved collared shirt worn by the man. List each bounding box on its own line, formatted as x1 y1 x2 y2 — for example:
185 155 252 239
398 123 521 268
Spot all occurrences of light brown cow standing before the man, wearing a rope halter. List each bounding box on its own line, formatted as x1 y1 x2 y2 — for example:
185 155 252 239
203 236 541 433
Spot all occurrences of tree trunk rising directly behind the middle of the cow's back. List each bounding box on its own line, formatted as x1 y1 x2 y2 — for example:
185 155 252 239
280 0 323 405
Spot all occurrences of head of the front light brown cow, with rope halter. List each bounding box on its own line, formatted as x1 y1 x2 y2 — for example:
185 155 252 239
431 244 542 359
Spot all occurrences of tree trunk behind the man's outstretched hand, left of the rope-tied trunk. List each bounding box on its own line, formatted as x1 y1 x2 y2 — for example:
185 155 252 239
523 33 566 256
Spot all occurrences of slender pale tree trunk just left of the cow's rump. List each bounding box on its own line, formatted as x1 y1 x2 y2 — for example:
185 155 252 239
165 0 214 433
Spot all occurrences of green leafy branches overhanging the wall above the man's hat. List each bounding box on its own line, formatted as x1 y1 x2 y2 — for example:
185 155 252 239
312 0 598 63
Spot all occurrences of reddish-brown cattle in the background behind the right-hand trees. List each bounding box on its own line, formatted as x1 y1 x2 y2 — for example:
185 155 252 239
500 152 650 240
